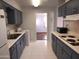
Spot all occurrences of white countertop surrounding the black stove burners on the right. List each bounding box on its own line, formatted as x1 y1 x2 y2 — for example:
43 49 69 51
52 32 79 54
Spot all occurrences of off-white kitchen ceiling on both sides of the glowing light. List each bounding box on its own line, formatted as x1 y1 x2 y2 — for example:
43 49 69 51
16 0 57 7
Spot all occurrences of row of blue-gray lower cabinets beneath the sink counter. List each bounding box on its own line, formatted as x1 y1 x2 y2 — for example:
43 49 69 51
9 34 26 59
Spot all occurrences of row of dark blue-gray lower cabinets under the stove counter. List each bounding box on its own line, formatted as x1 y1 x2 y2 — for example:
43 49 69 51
52 34 79 59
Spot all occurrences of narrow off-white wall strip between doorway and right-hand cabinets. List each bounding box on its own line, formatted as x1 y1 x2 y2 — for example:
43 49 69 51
47 7 57 44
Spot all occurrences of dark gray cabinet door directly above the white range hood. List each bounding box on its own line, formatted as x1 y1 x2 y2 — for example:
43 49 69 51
67 0 79 15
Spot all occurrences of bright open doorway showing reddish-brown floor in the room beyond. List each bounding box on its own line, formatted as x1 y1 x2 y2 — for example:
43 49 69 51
36 13 47 40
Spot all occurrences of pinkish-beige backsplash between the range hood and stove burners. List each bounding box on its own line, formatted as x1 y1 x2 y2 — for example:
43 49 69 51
64 20 79 33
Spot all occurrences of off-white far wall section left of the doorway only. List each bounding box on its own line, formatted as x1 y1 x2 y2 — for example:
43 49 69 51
21 9 36 41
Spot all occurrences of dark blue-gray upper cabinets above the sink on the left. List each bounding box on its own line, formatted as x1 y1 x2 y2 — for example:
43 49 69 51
0 1 22 26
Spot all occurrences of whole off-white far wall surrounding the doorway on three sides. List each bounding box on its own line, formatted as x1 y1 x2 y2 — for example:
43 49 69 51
22 8 54 41
